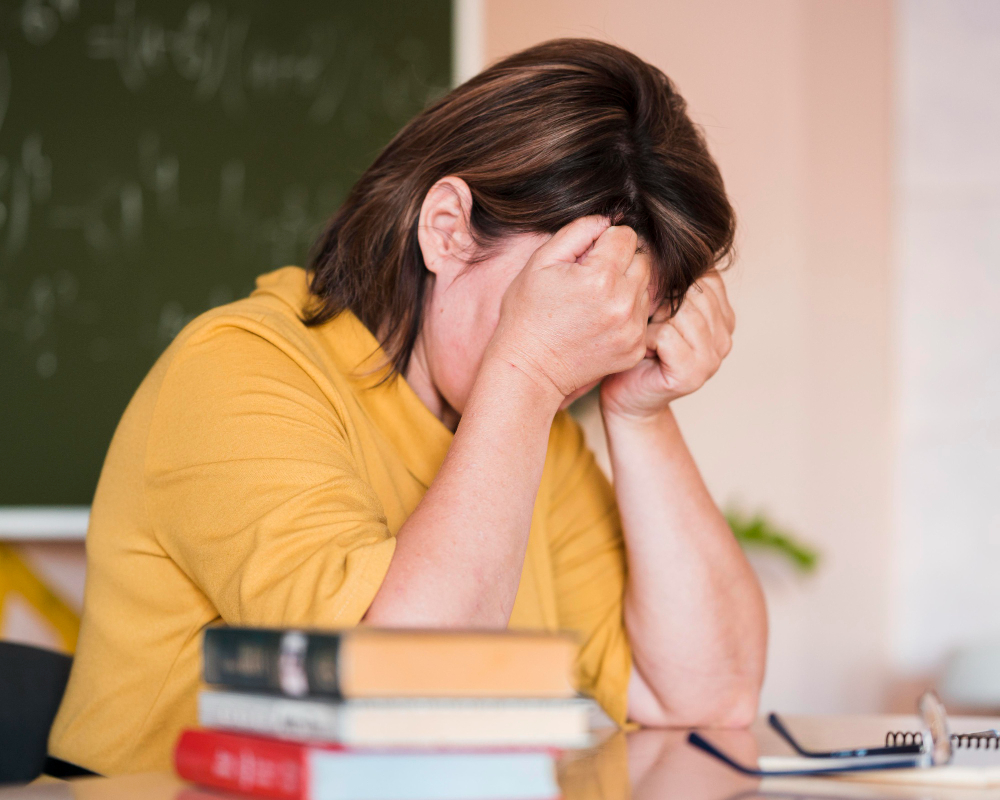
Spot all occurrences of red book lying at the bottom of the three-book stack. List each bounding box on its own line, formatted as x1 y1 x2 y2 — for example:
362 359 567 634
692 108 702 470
174 730 559 800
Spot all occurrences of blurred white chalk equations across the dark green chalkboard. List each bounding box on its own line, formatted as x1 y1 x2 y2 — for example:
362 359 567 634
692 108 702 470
0 0 442 378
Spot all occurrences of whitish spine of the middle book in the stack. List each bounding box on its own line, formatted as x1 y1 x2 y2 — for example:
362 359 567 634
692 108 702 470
198 691 340 742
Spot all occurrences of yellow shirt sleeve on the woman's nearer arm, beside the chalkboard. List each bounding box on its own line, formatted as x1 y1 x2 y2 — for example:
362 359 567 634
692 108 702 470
145 327 395 627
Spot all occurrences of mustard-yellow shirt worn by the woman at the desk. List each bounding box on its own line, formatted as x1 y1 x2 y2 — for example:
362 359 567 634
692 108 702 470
49 267 631 774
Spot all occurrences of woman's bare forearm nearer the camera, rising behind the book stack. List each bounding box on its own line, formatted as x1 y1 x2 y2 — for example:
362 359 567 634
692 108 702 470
365 354 562 628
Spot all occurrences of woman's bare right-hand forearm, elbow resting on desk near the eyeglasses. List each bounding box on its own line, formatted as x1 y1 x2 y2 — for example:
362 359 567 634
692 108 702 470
605 408 767 725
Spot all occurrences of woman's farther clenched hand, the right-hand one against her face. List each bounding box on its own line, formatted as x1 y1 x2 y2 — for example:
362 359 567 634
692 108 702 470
601 269 736 420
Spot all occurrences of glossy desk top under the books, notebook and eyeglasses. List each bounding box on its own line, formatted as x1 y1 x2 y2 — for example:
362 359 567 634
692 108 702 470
0 716 1000 800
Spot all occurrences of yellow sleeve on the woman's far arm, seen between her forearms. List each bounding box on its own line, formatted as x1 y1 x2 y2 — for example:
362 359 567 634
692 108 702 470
549 413 632 724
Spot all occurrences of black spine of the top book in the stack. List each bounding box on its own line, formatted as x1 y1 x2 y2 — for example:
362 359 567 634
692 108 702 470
203 628 341 699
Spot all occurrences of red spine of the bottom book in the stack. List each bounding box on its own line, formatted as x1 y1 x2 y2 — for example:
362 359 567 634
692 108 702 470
174 730 311 800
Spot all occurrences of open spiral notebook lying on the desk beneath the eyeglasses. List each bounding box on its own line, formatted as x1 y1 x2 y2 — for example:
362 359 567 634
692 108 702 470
758 731 1000 789
